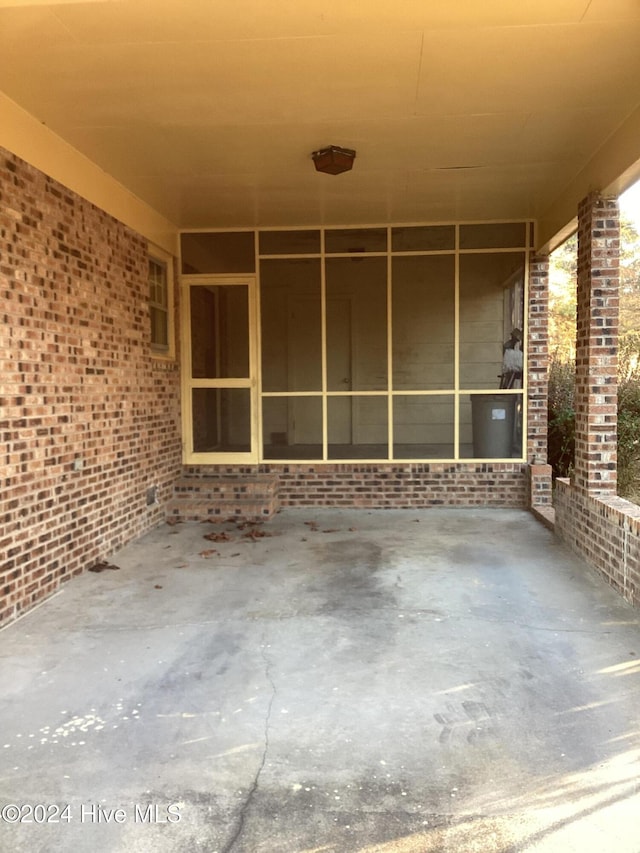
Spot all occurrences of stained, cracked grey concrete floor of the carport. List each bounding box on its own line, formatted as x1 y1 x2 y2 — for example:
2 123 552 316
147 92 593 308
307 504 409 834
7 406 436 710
0 509 640 853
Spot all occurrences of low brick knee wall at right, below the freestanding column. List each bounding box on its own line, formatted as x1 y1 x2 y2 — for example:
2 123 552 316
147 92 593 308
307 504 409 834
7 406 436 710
554 479 640 607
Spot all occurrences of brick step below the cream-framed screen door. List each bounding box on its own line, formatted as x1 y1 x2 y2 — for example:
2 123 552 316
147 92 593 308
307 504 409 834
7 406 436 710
167 474 280 521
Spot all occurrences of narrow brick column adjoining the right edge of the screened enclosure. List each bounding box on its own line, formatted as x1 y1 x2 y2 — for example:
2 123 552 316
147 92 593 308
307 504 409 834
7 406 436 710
526 255 552 506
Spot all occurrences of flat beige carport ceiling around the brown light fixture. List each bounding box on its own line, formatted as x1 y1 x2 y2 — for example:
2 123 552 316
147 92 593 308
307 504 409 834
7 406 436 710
0 0 640 241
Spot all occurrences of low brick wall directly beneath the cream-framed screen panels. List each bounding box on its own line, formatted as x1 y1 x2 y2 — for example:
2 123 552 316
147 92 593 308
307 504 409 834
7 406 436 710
185 462 528 509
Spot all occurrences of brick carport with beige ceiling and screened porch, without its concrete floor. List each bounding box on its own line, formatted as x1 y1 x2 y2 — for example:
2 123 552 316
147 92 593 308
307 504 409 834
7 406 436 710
0 0 640 625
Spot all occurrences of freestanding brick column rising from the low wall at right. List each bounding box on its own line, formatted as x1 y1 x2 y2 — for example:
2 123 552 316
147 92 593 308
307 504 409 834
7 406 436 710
573 193 620 495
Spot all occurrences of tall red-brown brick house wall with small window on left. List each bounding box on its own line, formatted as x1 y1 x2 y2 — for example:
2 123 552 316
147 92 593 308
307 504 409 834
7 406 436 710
0 149 180 623
